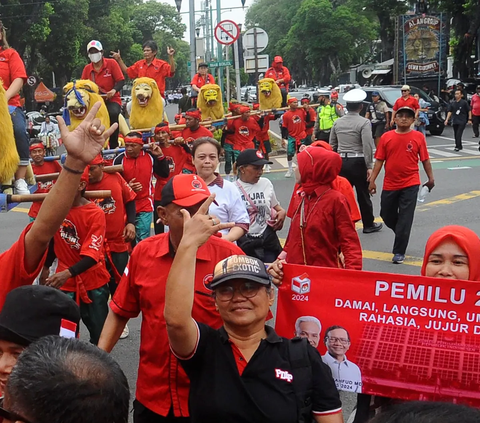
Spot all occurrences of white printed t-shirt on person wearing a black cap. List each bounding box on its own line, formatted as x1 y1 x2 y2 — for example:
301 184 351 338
237 178 280 236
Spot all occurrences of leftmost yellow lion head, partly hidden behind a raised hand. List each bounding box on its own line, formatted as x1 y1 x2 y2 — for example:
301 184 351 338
63 79 110 131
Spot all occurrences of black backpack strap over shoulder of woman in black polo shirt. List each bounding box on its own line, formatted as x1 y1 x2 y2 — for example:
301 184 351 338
287 336 313 423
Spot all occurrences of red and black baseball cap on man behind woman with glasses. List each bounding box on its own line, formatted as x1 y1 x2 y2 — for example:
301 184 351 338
160 174 210 207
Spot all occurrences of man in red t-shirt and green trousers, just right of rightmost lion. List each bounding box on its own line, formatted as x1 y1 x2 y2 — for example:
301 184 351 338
282 97 310 178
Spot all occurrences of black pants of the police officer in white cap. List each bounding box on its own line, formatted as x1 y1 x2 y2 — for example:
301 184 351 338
340 157 375 228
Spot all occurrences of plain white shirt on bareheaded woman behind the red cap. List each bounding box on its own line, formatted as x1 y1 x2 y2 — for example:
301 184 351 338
208 180 250 234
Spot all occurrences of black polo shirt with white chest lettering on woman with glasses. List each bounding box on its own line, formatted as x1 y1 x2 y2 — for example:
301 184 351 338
180 323 341 423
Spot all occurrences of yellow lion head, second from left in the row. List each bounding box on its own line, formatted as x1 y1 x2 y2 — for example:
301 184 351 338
130 77 163 129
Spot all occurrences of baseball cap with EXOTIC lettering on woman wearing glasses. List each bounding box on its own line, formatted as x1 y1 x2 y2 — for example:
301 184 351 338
207 256 271 289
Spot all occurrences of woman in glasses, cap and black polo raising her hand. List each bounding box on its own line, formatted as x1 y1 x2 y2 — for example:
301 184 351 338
164 196 343 423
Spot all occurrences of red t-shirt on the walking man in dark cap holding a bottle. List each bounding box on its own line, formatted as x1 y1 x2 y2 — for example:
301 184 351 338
375 131 429 191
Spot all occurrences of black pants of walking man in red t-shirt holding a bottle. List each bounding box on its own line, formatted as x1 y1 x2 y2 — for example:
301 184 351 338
380 185 419 254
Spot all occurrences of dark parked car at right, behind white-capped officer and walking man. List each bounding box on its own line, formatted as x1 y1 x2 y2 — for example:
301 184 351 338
362 85 447 135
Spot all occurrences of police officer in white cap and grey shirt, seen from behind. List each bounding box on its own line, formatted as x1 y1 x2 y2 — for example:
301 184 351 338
330 88 383 234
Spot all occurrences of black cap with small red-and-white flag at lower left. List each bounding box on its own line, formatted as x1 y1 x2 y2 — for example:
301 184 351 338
0 285 80 346
